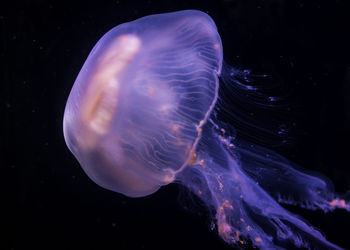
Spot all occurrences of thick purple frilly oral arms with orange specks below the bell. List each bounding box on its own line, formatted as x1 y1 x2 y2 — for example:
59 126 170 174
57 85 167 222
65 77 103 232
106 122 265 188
177 123 341 249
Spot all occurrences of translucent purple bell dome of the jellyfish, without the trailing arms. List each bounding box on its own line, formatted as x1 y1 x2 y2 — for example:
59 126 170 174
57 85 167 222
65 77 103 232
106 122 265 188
63 10 222 197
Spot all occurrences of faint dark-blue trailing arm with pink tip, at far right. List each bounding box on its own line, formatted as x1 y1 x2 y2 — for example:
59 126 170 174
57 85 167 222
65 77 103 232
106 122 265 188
234 143 350 212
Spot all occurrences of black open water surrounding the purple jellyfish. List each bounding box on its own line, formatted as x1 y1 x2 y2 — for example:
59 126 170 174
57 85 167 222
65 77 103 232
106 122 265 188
0 0 350 249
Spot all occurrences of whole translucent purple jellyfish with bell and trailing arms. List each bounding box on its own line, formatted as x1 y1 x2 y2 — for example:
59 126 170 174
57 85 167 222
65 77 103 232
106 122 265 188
63 10 350 249
